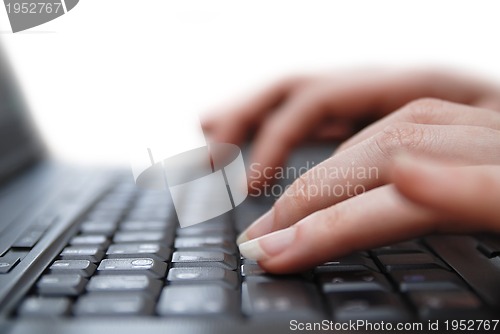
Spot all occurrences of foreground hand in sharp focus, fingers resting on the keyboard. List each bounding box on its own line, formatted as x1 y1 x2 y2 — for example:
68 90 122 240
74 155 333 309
238 99 500 273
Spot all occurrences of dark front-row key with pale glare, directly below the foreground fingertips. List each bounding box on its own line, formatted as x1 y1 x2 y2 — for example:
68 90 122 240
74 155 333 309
242 277 320 319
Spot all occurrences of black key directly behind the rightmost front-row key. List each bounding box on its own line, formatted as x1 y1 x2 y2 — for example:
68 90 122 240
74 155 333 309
390 269 465 292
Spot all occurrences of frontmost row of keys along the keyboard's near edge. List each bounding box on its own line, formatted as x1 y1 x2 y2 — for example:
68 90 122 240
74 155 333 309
28 276 483 321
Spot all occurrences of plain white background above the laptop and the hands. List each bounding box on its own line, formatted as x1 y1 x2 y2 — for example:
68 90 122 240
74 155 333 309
0 0 500 163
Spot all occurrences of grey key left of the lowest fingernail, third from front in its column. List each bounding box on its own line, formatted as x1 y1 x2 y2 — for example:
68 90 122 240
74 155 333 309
172 251 237 270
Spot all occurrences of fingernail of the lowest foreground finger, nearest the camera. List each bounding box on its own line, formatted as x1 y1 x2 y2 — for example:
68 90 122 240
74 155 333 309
240 227 296 261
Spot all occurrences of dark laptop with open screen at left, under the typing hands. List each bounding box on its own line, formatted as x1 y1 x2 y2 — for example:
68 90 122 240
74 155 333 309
0 43 500 334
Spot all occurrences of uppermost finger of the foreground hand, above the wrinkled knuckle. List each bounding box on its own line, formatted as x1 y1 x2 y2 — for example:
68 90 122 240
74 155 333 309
336 98 500 153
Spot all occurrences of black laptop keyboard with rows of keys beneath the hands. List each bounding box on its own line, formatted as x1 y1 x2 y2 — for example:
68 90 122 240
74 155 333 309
10 185 500 322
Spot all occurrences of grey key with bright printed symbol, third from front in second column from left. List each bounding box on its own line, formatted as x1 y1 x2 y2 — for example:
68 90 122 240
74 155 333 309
97 258 167 278
